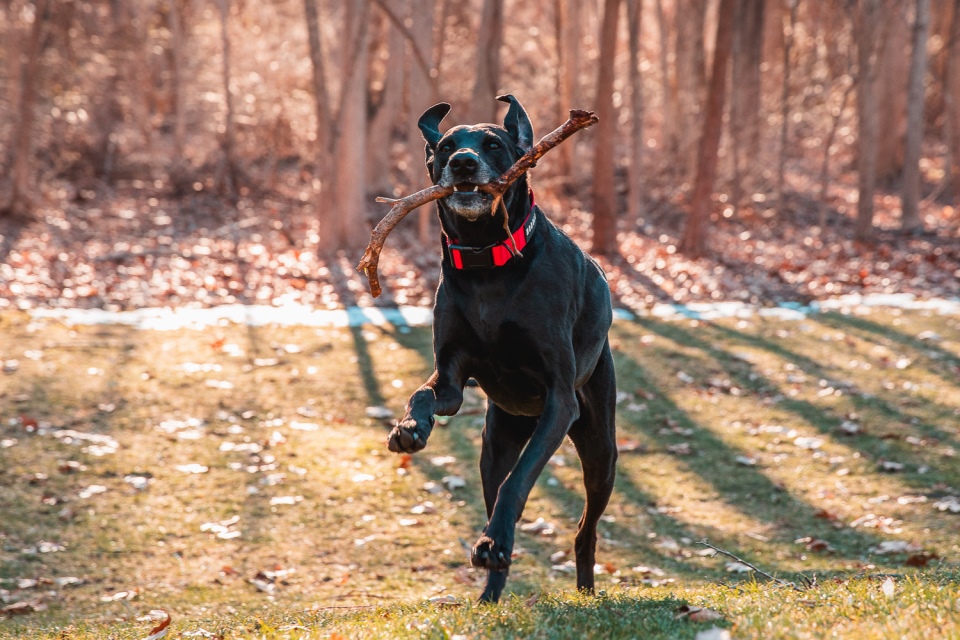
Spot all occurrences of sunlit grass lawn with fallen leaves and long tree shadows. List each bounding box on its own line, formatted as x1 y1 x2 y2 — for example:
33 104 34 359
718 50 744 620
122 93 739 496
0 311 960 640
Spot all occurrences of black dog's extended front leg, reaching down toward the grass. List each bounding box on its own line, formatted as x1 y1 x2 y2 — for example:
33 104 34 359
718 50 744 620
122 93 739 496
470 382 580 571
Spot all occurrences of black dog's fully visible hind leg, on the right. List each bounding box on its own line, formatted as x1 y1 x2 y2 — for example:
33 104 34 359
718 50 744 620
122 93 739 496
569 347 617 591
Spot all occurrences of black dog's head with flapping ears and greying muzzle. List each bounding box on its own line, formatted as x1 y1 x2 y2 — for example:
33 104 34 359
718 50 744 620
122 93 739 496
417 95 533 221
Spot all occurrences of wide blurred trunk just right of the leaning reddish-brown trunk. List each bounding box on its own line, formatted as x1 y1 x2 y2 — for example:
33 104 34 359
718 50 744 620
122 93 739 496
730 0 766 206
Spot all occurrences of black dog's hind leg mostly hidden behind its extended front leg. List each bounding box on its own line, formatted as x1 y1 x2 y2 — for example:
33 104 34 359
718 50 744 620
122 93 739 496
480 402 537 602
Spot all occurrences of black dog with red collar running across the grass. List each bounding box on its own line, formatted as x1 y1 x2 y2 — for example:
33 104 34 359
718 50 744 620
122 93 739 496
387 95 617 602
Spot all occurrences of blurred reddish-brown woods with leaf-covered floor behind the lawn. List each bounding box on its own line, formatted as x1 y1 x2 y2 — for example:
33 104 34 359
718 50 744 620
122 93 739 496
0 0 960 309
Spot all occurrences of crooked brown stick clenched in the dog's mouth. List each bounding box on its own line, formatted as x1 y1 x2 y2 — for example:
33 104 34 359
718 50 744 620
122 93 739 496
357 109 599 298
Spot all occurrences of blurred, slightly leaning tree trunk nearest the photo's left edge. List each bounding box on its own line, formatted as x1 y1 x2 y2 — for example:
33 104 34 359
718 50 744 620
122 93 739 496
0 0 48 218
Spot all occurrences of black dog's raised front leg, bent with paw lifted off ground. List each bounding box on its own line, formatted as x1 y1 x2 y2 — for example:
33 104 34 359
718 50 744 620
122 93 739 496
387 361 466 453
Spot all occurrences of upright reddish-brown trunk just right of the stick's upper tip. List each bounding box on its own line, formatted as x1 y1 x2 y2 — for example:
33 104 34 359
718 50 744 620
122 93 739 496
593 0 620 254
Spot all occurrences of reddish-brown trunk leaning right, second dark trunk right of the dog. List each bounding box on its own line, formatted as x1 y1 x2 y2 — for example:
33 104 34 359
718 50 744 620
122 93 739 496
680 0 736 258
